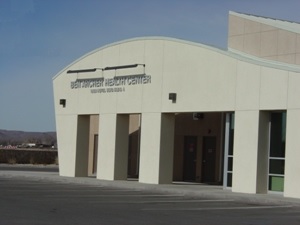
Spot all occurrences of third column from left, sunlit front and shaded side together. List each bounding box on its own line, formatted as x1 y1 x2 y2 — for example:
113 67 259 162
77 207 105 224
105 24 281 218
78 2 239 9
139 113 175 184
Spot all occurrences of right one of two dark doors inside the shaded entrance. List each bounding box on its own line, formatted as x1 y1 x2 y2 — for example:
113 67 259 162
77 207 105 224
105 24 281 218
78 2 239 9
202 137 216 183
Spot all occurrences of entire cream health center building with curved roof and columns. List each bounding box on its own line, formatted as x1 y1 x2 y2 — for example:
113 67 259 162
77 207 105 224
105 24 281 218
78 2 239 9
53 12 300 198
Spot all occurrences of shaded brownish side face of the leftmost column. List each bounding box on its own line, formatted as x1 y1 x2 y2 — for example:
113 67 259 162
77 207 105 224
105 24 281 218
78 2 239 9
75 116 90 177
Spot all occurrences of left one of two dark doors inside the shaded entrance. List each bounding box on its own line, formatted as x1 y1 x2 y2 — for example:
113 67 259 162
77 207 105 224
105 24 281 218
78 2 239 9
183 136 197 181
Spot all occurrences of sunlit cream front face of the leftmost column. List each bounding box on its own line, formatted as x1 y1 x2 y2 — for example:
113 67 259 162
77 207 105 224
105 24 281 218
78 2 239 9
56 115 77 177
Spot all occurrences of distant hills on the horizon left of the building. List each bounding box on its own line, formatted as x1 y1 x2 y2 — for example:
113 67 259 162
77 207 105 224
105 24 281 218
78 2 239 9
0 129 56 145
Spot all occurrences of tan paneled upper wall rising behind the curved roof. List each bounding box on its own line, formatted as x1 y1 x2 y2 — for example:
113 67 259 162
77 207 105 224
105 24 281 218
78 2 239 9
228 13 300 65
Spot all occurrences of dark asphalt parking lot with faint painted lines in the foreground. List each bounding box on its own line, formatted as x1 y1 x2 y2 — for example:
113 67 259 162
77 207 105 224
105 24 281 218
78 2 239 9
0 164 300 225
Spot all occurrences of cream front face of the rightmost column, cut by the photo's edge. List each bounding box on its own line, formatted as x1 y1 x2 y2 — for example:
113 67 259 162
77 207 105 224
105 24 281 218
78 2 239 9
284 109 300 198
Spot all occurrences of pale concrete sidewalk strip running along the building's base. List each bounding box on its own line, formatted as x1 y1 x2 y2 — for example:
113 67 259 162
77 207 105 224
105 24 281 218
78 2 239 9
0 165 300 206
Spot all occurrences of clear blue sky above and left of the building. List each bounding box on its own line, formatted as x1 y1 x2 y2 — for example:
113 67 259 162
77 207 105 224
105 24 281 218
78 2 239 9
0 0 300 131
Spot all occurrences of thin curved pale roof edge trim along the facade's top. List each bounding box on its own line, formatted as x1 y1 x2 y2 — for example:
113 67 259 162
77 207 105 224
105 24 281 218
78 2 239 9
52 36 300 80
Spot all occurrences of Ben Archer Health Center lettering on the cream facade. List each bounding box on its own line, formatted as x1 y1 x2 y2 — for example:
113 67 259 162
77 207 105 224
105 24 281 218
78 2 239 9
70 74 151 94
